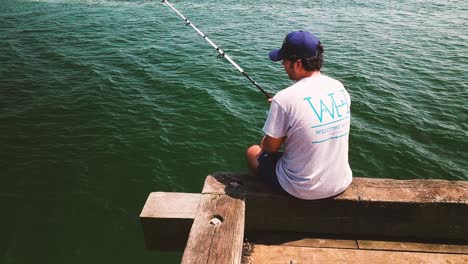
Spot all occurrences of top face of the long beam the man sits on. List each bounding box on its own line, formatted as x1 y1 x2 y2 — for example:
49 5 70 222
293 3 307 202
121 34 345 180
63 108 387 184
203 172 468 204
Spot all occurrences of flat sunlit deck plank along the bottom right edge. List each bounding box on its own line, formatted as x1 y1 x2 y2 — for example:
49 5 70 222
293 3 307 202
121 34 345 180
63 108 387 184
248 245 468 264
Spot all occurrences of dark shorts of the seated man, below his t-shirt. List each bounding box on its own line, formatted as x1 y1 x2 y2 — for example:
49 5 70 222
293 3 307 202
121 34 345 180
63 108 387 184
257 151 285 192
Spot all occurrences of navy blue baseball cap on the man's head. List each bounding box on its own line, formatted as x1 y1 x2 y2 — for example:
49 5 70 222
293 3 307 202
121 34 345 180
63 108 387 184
268 30 320 61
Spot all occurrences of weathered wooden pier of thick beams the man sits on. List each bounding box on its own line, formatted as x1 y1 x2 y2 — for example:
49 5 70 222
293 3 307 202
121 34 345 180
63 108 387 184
140 172 468 264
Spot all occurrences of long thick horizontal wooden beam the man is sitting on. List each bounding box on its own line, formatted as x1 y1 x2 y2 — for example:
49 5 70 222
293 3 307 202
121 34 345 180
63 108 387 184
203 172 468 241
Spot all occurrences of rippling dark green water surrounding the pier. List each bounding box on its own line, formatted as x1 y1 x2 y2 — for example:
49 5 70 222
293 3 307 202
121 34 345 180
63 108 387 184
0 0 468 264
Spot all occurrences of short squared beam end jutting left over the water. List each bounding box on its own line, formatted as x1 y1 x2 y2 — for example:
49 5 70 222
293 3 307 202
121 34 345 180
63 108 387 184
140 192 201 251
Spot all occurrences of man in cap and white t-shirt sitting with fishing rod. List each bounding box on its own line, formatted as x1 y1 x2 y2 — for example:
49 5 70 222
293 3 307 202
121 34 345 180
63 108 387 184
246 31 352 200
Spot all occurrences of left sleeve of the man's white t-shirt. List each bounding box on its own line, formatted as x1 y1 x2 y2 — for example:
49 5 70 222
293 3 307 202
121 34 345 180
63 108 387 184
263 100 289 138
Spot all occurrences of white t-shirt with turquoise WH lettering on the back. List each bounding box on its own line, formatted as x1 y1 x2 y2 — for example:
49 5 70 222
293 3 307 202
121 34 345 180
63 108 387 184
263 75 352 200
